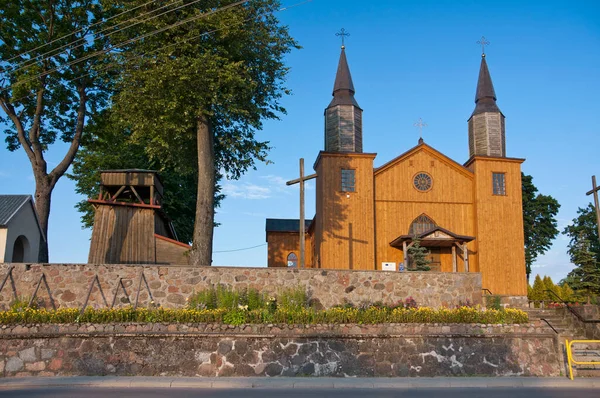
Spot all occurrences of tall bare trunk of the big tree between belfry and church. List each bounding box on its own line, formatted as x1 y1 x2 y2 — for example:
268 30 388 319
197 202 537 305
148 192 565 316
190 116 215 265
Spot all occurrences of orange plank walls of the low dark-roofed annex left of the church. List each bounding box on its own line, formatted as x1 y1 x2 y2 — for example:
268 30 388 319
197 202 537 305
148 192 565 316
267 232 313 268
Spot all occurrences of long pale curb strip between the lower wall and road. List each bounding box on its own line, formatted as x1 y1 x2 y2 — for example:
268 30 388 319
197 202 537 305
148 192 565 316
0 376 600 390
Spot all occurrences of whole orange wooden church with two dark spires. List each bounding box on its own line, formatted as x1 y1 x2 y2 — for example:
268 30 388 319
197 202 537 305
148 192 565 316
266 46 527 296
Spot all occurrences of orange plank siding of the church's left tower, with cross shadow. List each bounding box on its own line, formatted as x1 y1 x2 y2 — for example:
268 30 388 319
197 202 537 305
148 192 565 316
314 152 375 270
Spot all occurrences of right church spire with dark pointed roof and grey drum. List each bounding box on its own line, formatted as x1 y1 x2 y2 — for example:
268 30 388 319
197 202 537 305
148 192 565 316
469 53 506 157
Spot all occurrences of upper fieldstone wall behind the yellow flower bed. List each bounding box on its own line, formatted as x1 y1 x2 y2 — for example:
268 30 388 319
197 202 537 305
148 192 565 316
0 264 482 308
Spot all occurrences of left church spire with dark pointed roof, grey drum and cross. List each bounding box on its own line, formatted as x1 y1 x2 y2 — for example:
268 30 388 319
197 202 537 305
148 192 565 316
325 29 362 153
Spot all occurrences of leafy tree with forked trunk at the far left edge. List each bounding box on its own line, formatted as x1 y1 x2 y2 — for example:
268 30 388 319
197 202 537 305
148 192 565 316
0 0 112 262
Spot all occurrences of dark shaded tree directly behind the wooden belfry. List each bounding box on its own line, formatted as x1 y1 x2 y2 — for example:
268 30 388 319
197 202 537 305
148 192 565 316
68 109 223 242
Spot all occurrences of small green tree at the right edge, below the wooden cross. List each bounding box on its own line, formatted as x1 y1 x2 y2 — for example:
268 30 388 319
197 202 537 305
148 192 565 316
566 232 600 295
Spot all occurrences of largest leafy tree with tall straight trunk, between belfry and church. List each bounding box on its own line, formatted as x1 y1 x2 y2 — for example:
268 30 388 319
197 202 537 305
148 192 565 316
108 0 297 265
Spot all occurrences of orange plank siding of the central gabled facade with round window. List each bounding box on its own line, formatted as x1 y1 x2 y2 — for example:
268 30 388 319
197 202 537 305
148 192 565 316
375 145 478 272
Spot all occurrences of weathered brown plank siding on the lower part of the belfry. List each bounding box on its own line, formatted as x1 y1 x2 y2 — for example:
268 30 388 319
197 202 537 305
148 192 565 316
88 205 156 264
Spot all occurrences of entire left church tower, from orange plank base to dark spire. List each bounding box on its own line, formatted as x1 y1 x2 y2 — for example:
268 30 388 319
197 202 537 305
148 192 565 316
313 42 375 270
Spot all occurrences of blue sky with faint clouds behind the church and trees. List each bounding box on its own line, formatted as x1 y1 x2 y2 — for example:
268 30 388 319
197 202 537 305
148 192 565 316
0 0 600 281
